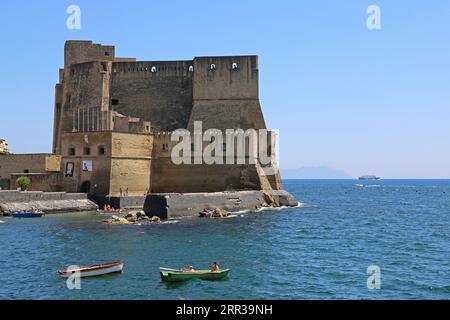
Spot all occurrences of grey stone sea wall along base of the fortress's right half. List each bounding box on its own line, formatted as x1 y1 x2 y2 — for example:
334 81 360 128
144 190 298 219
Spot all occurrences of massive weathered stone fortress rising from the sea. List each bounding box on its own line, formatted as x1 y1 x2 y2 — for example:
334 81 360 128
0 41 297 215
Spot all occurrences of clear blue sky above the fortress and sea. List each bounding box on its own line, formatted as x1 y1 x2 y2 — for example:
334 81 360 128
0 0 450 178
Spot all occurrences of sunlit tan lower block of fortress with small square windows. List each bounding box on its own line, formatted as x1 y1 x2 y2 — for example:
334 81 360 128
62 131 153 196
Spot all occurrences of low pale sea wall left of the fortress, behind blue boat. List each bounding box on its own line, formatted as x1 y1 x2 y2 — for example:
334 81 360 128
0 191 98 215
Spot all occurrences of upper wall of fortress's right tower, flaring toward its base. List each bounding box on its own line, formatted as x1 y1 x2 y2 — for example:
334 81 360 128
188 56 266 131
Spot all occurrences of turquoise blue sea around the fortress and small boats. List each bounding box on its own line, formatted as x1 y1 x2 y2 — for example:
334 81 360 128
0 180 450 299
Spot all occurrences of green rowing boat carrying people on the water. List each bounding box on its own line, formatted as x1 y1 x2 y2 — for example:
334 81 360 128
159 268 230 282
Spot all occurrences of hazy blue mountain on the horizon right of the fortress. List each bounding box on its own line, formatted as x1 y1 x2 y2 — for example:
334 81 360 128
281 166 355 179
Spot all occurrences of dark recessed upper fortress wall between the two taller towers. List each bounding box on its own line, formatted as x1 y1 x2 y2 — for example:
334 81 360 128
110 61 192 130
